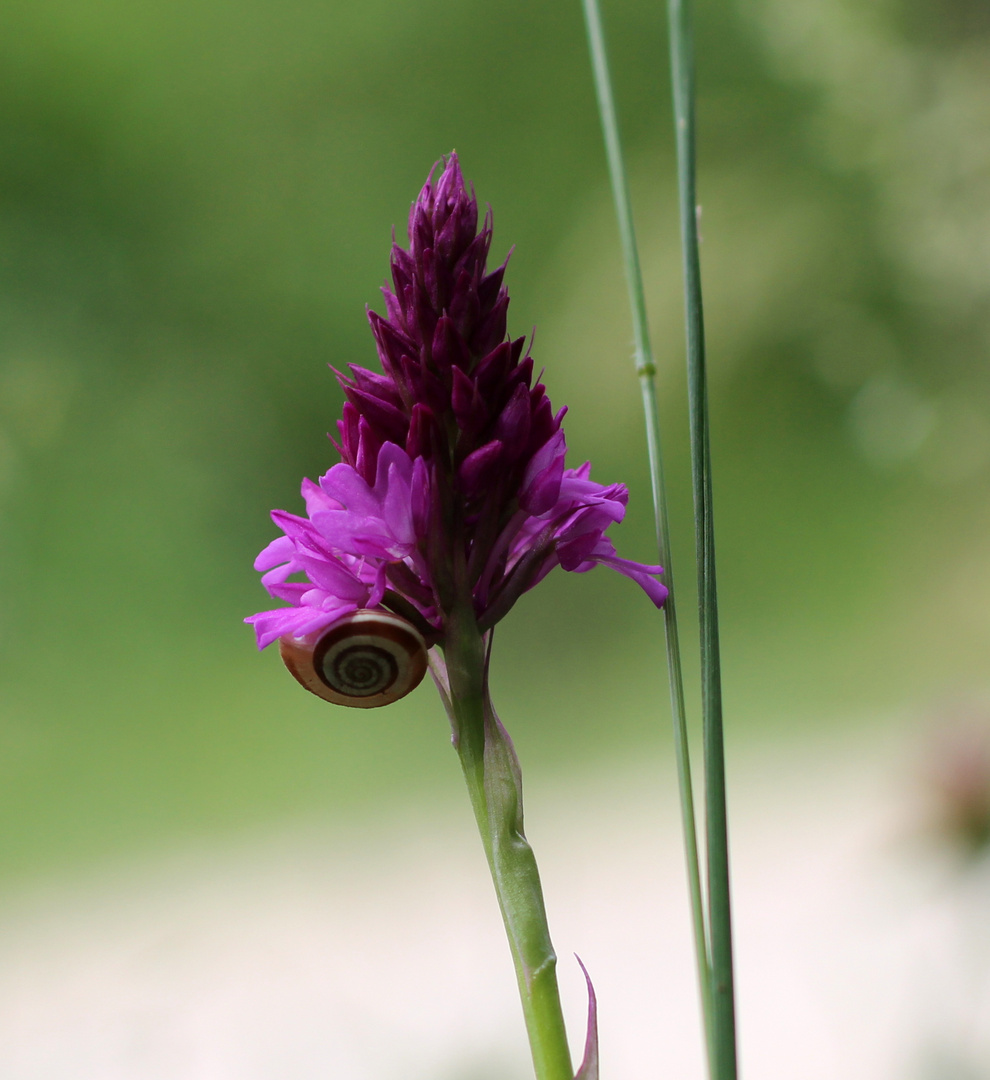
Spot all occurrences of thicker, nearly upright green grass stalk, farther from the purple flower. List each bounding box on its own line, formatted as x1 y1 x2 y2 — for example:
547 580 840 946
667 0 736 1080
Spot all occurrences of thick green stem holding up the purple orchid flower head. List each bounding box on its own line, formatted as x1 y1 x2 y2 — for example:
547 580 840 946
442 605 574 1080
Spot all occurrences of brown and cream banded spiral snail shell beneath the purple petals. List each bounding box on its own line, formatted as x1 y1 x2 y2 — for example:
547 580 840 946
279 610 426 708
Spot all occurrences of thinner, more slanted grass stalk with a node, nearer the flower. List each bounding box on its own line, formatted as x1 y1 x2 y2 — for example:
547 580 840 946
582 0 713 1062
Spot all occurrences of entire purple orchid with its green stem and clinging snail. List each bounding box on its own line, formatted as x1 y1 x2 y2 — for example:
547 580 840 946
246 154 666 1080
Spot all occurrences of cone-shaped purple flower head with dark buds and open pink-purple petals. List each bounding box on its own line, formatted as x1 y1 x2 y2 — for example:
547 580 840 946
246 154 667 648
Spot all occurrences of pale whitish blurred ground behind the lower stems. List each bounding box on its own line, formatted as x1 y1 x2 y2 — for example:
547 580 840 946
0 725 990 1080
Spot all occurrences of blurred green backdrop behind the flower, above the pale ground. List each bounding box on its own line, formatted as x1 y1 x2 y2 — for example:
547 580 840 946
0 0 990 887
